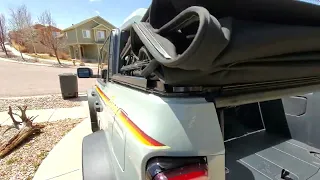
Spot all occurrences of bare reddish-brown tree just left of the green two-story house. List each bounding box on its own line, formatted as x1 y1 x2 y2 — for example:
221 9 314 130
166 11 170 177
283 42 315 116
38 11 65 64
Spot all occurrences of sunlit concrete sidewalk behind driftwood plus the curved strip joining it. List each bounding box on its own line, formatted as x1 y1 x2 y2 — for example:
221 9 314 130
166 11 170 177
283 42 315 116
0 101 92 180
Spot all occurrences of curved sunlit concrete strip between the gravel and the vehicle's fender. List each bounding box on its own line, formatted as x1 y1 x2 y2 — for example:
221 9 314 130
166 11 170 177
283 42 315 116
33 118 92 180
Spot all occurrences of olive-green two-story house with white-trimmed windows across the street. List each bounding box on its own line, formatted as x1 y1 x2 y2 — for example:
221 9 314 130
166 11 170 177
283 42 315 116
62 16 115 62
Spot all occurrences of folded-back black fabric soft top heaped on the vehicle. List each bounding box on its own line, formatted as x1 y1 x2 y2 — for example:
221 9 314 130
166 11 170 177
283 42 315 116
120 0 320 97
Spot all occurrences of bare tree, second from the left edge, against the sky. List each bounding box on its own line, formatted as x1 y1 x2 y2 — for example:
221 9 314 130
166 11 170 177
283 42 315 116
9 5 36 59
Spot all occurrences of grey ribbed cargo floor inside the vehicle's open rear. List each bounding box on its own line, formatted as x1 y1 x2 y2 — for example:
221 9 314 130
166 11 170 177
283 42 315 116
225 131 320 180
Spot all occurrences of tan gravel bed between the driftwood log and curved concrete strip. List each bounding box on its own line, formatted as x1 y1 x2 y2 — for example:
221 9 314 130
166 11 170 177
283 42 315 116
0 119 82 180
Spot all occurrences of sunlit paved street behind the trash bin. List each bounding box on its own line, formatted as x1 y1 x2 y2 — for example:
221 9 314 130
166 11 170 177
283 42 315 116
0 61 95 97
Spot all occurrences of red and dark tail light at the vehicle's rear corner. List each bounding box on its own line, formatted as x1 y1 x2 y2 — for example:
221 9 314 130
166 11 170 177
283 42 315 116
146 157 209 180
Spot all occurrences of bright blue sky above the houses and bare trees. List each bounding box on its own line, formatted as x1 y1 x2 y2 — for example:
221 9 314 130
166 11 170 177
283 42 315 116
0 0 151 29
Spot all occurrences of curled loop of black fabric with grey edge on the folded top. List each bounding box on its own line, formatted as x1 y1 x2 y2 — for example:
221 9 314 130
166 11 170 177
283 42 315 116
131 6 230 70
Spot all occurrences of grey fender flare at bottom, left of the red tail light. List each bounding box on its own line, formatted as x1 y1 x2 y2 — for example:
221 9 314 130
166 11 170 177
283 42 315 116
82 130 116 180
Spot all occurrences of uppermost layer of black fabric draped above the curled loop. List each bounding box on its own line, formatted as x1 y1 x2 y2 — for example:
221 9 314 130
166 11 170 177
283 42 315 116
145 0 320 28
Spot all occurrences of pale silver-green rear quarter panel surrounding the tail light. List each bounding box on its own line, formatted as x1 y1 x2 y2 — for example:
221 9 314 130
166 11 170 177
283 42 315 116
99 83 224 180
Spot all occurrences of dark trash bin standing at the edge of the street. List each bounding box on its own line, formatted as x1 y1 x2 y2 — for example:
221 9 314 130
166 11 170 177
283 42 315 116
59 73 78 99
